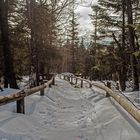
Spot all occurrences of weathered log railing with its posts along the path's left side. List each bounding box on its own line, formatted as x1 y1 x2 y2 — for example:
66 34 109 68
0 76 55 114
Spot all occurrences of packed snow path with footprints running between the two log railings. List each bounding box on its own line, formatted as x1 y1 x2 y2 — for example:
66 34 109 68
0 78 140 140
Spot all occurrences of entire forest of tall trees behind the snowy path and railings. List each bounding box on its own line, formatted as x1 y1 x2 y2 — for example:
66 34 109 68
0 0 140 91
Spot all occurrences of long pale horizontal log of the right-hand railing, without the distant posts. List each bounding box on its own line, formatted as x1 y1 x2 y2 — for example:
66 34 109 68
61 75 140 123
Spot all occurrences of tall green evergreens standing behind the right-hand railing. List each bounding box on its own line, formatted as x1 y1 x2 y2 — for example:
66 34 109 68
91 0 140 91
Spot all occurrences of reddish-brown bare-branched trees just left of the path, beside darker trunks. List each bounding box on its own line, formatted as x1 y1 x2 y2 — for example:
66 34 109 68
27 0 74 84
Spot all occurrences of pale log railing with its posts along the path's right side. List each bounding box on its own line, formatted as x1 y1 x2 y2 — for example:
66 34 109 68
60 74 140 123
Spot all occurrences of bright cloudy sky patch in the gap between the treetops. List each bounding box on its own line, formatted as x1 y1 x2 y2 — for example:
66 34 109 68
76 0 97 35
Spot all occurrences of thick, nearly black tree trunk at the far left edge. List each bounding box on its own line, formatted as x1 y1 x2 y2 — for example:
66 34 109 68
0 0 18 88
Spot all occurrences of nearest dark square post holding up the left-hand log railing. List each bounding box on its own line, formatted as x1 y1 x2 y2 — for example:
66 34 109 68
17 98 25 114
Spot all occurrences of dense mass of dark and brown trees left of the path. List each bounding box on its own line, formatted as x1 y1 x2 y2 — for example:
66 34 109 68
0 0 75 88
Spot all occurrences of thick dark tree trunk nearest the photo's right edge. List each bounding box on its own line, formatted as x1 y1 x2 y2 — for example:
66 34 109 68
126 0 139 91
